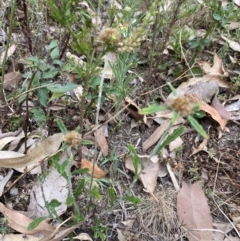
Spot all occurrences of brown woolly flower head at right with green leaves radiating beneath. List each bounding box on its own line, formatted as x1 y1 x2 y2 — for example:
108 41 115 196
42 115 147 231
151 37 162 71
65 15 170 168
169 96 193 116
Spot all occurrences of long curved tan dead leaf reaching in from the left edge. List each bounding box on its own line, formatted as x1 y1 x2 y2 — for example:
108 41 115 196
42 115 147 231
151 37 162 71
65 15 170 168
0 133 63 168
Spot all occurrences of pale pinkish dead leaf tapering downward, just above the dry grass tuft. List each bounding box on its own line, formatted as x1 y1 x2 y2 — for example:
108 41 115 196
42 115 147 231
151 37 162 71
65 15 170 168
125 155 160 194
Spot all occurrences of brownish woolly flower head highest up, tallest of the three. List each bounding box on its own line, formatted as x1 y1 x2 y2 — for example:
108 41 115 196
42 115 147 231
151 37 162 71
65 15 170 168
98 28 121 47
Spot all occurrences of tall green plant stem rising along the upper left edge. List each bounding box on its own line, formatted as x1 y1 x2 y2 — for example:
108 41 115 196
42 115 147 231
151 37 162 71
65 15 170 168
0 0 17 103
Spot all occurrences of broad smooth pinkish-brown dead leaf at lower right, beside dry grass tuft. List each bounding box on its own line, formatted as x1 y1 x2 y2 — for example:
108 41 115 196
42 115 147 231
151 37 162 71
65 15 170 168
177 182 212 241
